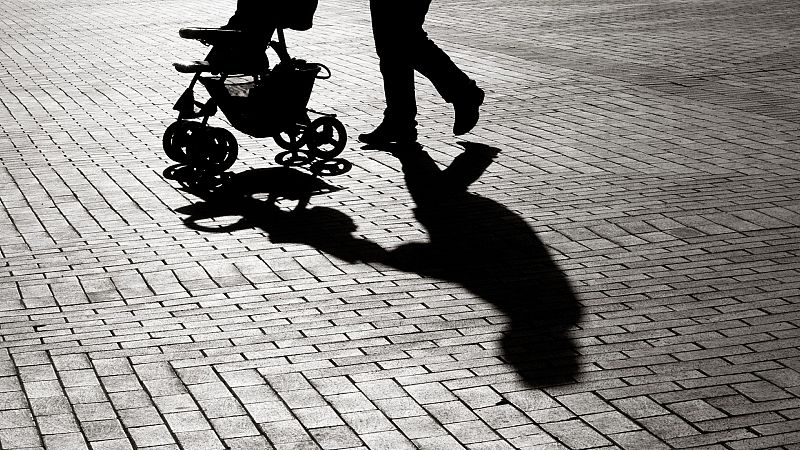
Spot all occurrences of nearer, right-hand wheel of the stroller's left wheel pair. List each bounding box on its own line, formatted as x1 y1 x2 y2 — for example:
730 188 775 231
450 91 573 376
187 127 239 174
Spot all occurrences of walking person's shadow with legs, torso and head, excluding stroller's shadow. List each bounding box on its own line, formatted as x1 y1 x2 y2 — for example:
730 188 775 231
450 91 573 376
376 142 580 386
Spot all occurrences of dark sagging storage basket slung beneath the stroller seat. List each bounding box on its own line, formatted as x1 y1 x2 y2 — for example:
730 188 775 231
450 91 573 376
199 60 322 138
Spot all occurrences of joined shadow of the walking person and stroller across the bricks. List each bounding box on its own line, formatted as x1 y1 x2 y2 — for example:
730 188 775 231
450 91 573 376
173 142 580 386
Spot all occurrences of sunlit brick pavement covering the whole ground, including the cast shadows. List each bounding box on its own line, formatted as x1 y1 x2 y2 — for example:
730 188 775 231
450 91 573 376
0 0 800 450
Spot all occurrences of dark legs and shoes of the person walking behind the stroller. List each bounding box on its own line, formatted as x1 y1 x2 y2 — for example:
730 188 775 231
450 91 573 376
359 0 484 145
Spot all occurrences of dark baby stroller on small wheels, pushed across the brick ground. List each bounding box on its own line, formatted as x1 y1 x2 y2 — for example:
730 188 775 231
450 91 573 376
163 0 352 177
